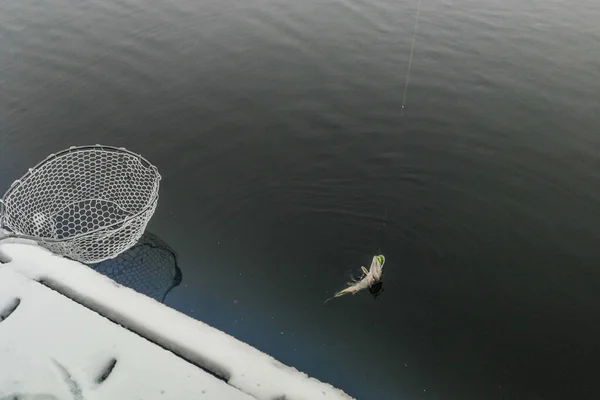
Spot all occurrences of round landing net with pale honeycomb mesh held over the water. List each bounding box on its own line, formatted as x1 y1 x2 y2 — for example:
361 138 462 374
2 146 160 264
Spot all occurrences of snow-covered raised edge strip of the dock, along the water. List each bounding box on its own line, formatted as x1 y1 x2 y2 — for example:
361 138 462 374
0 241 351 400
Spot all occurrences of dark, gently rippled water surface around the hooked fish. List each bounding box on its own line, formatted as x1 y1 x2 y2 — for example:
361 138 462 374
0 0 600 399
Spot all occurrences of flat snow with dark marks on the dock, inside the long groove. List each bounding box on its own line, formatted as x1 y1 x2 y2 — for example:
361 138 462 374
0 264 253 400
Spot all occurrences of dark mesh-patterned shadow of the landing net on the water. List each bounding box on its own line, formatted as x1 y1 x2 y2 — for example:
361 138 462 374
90 231 182 303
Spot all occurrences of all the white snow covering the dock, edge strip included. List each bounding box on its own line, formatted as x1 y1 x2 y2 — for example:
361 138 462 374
0 240 351 400
